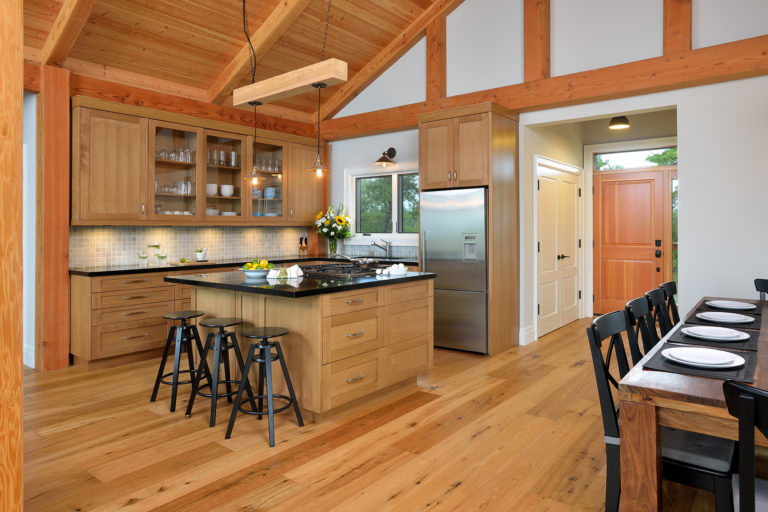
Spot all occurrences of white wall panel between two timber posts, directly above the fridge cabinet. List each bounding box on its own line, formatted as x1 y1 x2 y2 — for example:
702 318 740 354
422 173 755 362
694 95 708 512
445 0 523 96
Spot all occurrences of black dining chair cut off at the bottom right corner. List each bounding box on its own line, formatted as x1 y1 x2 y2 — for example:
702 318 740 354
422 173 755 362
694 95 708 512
723 380 768 512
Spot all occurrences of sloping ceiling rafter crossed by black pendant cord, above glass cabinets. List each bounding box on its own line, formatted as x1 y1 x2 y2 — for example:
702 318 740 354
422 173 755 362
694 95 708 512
207 0 312 103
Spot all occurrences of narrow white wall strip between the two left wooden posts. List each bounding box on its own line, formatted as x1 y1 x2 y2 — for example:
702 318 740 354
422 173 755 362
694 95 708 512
21 92 37 368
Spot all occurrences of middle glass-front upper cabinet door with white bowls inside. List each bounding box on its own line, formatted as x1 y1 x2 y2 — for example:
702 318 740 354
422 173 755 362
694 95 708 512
205 130 247 222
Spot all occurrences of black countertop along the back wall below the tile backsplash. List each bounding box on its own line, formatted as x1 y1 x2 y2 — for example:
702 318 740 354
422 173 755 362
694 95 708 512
69 256 419 277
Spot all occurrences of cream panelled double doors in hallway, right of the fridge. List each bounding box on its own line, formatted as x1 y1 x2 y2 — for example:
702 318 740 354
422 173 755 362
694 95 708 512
537 160 581 336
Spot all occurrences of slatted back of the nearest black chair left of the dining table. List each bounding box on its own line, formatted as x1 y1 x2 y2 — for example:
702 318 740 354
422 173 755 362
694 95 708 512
587 311 629 439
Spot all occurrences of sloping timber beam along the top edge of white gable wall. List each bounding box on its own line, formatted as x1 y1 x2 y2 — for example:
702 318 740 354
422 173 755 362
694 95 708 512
320 0 462 119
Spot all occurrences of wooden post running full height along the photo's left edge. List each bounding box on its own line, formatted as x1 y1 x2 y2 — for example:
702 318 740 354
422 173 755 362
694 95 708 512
0 0 24 512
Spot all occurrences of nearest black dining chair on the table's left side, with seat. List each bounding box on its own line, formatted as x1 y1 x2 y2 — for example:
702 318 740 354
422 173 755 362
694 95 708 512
587 310 734 512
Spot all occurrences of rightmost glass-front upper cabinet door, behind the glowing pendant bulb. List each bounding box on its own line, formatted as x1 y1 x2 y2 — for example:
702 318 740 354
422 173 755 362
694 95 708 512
246 137 286 221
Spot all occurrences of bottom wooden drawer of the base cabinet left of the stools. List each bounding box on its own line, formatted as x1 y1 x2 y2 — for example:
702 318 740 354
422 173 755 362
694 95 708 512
91 319 168 358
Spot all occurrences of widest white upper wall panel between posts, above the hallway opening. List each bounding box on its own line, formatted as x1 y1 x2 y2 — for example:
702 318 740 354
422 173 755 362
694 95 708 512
550 0 664 76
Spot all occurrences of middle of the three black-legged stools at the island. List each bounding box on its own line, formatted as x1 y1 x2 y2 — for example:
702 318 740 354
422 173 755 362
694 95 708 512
186 318 252 427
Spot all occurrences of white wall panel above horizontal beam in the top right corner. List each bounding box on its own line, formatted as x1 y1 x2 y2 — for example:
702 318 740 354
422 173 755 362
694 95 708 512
691 0 768 48
